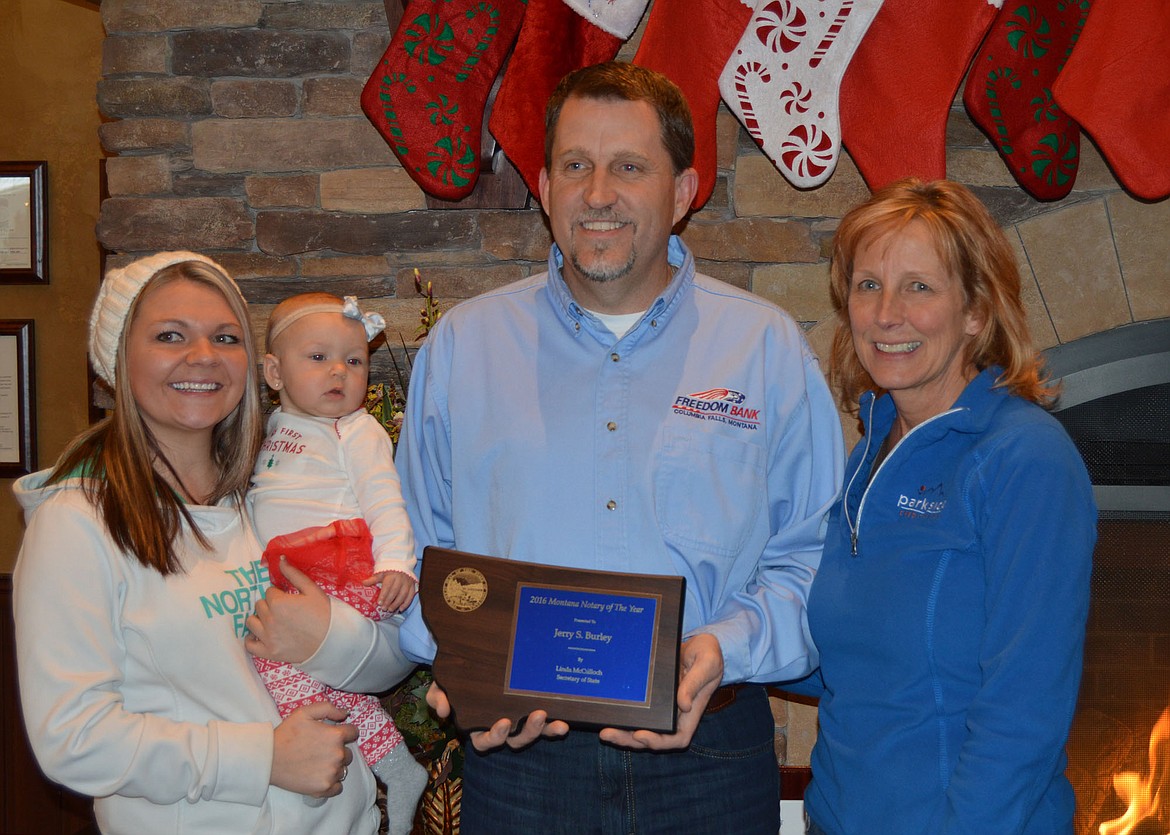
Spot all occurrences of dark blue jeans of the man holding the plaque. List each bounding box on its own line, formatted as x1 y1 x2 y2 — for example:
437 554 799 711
460 686 780 835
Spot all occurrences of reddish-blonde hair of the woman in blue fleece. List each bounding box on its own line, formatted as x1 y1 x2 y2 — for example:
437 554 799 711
828 178 1055 414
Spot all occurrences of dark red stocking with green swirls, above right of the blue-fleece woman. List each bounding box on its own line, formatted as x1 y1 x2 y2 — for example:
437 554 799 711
963 0 1092 200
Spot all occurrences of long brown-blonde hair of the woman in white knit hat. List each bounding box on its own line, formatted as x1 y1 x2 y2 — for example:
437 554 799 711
49 261 263 574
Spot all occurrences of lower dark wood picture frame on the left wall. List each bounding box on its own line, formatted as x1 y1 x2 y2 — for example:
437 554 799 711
0 319 36 478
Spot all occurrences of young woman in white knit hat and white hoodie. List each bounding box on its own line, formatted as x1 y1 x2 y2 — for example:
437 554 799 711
15 253 408 835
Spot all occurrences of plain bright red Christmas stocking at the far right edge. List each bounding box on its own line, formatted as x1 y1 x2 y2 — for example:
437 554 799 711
1052 0 1170 200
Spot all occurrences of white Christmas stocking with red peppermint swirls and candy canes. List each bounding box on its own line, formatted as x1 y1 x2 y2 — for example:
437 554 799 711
720 0 882 188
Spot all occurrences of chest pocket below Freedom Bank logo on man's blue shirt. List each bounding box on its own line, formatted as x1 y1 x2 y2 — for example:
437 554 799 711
654 428 768 557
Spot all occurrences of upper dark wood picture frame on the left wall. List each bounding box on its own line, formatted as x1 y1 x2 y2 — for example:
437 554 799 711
0 160 49 284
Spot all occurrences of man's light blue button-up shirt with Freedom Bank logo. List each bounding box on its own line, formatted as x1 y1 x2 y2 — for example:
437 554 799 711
397 237 844 683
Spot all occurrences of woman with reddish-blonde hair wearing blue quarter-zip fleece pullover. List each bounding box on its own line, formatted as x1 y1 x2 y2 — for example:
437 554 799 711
796 180 1096 835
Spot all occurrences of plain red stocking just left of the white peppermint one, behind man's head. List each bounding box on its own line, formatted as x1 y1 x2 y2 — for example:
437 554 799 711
634 0 751 208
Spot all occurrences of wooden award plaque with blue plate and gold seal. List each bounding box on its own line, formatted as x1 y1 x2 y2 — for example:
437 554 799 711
419 546 686 733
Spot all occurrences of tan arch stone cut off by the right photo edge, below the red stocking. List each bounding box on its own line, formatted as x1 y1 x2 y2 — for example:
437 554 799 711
1106 192 1170 322
